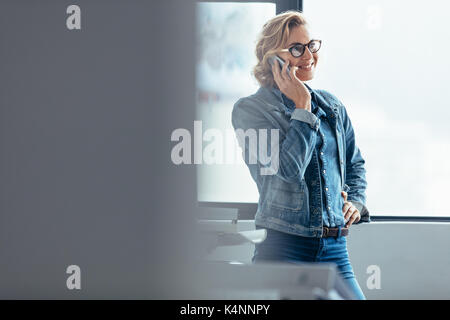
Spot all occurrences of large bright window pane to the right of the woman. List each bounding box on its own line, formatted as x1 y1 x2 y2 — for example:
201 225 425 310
303 0 450 217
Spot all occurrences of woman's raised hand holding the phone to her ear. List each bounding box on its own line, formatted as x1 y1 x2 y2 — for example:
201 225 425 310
272 60 311 112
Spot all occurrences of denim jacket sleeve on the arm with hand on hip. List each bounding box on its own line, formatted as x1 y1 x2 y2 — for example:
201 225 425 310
341 104 370 223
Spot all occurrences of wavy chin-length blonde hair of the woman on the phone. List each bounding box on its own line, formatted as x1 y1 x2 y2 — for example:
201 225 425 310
252 10 307 87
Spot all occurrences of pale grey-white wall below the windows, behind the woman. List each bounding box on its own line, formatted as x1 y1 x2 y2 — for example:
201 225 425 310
202 220 450 299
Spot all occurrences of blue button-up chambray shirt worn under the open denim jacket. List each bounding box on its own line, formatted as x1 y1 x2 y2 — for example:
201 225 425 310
272 86 345 227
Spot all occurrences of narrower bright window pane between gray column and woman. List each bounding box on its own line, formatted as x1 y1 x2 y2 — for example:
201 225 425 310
196 2 276 203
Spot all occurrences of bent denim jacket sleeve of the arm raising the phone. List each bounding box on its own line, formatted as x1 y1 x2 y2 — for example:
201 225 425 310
232 97 320 183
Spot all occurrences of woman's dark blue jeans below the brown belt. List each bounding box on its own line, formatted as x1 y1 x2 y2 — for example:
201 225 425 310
252 227 366 300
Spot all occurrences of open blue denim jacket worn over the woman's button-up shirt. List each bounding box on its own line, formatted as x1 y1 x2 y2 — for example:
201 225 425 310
232 86 370 237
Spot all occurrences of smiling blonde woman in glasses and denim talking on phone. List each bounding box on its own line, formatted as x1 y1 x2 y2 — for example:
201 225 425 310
232 11 370 299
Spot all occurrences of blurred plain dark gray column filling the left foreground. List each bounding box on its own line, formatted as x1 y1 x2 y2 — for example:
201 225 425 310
0 0 196 299
